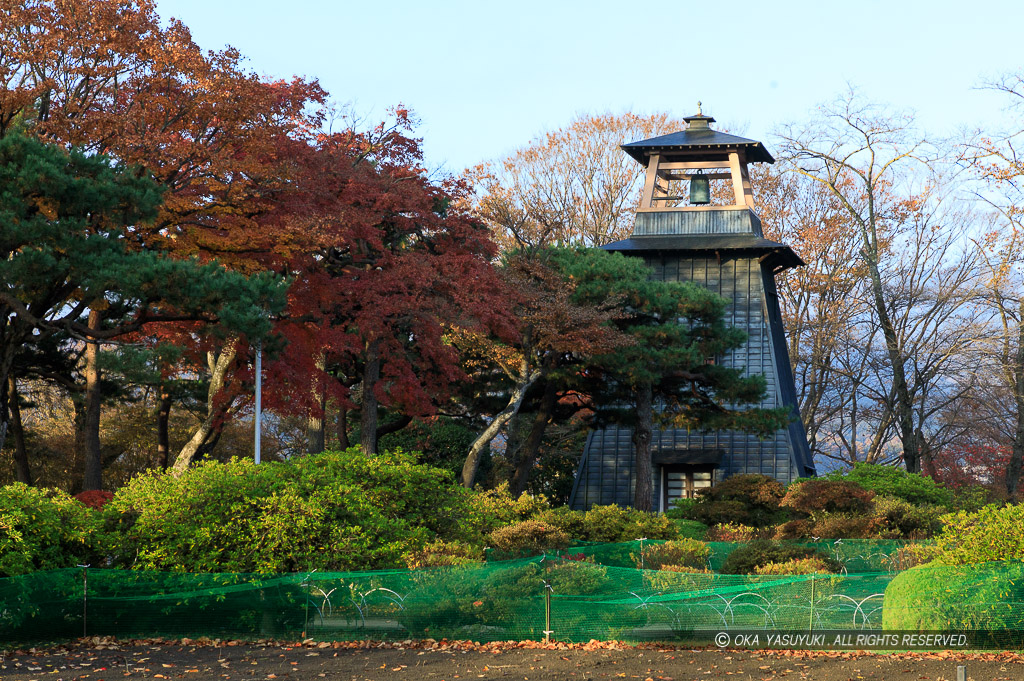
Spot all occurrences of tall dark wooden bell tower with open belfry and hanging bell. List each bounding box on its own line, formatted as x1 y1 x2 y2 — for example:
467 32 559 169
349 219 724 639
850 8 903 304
569 104 815 511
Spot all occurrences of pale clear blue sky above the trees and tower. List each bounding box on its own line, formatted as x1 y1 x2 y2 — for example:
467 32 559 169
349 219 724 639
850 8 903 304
158 0 1024 172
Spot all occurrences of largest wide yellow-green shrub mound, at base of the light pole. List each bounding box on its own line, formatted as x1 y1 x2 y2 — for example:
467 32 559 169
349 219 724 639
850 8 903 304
103 449 482 572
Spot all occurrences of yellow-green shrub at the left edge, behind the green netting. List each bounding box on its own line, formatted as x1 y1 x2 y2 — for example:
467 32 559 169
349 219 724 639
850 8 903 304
0 482 100 578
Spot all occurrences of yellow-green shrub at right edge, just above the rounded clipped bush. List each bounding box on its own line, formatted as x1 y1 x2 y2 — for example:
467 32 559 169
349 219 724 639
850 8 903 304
934 504 1024 565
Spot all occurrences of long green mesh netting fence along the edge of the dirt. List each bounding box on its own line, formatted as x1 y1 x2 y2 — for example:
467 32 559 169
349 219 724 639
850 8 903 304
0 543 1024 641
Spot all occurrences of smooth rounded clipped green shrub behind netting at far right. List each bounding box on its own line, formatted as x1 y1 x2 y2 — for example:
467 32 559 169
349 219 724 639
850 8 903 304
882 562 1024 631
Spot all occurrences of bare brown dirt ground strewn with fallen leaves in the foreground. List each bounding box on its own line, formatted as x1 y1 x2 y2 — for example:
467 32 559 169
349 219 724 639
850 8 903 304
0 639 1024 681
